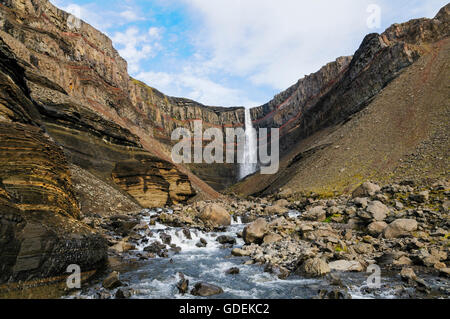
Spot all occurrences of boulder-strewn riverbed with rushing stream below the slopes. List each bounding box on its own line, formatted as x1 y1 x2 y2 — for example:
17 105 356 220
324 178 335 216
67 181 450 298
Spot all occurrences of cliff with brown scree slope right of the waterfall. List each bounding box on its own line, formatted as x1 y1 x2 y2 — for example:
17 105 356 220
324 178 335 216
232 5 450 194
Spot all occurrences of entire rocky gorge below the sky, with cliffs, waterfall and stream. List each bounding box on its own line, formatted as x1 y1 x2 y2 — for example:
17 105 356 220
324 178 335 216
0 0 450 298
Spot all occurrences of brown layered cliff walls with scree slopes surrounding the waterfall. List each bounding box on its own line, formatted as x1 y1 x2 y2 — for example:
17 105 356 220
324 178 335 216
0 0 450 288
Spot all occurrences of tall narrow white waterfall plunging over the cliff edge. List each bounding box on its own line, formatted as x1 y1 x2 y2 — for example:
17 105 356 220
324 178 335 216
239 108 258 179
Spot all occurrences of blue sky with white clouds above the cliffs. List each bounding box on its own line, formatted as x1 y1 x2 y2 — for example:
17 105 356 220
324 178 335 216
50 0 447 107
